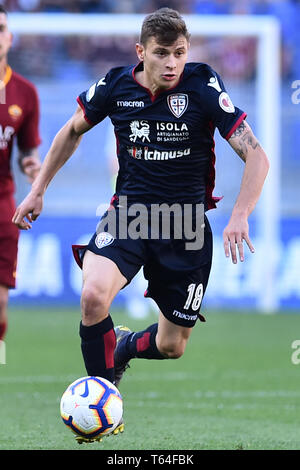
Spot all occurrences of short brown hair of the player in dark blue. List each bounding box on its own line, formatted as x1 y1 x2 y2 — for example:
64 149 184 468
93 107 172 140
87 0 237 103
140 8 190 46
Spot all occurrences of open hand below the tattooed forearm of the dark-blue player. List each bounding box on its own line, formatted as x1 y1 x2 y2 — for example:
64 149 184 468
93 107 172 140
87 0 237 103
223 216 255 264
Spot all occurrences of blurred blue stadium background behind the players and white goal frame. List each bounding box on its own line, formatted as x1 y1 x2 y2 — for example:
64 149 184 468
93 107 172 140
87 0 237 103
4 0 300 316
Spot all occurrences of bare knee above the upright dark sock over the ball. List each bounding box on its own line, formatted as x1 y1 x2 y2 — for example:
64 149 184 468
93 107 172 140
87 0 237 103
81 286 110 324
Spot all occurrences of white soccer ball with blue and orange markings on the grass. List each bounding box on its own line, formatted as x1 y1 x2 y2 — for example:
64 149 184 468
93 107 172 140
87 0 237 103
60 376 123 439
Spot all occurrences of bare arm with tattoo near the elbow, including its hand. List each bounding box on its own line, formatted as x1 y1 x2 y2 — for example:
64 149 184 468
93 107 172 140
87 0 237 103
223 121 269 263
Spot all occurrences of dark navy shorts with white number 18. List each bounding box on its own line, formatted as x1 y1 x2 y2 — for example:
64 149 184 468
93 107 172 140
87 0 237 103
73 213 212 327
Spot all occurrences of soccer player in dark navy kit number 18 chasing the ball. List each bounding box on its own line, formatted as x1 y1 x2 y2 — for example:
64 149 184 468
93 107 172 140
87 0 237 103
13 8 269 440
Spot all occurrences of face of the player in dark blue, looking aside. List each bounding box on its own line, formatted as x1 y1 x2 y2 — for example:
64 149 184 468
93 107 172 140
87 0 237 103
136 36 189 91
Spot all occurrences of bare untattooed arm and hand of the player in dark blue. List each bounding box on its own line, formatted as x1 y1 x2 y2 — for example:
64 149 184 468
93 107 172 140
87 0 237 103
12 106 93 230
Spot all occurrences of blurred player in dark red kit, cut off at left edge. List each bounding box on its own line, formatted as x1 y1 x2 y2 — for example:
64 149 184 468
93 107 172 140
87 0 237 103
0 5 40 340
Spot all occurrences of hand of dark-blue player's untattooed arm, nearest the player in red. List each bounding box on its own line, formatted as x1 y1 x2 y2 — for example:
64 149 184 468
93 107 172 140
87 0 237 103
12 191 43 230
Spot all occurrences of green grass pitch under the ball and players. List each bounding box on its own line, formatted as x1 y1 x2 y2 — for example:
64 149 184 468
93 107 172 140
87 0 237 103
0 308 300 450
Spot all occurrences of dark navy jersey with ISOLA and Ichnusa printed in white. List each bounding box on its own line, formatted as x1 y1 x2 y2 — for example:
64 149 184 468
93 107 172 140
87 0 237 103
77 63 246 210
